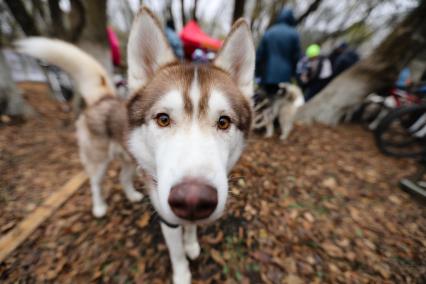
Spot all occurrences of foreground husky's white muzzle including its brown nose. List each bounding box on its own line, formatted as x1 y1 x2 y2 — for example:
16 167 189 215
151 123 228 223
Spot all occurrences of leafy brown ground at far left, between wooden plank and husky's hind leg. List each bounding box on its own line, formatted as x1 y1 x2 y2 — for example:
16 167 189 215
0 83 80 235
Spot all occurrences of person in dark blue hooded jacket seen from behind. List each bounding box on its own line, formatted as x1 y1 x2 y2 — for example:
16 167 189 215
256 9 300 94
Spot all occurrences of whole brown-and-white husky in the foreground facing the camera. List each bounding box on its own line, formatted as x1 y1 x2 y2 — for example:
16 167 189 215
17 8 255 283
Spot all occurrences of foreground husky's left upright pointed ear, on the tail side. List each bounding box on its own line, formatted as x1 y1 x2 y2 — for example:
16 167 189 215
127 7 176 90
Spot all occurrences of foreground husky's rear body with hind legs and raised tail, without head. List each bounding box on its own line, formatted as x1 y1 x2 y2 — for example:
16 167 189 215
15 37 143 217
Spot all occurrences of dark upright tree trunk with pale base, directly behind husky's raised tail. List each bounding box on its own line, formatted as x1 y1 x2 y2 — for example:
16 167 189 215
78 0 113 75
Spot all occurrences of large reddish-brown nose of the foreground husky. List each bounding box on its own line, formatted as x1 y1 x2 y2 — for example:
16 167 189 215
169 178 217 221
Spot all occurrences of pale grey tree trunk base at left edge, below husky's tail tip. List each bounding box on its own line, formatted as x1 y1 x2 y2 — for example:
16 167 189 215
0 49 35 118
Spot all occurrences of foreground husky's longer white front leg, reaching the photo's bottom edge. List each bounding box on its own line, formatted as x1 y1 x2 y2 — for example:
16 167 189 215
161 223 191 284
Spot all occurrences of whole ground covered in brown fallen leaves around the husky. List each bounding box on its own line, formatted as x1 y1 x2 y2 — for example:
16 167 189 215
0 83 426 283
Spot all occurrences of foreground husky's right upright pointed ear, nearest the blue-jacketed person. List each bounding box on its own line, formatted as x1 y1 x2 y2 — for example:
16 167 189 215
214 19 255 97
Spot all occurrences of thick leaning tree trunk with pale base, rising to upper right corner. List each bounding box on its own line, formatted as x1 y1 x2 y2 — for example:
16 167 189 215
298 1 426 125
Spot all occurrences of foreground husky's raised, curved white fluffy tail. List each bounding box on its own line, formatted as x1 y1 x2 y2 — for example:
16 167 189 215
14 37 116 105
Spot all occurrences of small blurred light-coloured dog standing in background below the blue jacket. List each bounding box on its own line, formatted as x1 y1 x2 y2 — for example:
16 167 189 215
253 83 305 140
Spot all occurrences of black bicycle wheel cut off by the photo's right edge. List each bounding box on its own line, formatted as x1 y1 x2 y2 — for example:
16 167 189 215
374 104 426 158
